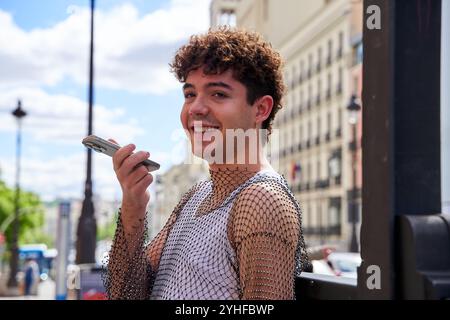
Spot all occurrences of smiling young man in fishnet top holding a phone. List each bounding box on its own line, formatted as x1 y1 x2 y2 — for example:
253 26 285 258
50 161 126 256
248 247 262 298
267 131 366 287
105 28 307 299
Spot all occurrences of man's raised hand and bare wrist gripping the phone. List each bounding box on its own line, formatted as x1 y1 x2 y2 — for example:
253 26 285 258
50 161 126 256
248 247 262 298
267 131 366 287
108 139 153 229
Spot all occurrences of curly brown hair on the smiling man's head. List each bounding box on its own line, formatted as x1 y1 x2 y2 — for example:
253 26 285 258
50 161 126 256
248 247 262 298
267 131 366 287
170 27 285 134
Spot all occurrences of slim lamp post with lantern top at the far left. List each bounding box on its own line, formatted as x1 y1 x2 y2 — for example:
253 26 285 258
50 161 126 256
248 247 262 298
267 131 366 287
8 100 27 288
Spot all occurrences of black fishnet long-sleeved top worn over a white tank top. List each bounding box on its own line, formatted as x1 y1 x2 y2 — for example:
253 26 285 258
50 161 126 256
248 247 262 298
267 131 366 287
104 170 309 300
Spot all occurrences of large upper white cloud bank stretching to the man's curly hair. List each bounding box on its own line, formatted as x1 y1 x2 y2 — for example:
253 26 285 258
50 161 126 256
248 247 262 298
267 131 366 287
0 0 210 94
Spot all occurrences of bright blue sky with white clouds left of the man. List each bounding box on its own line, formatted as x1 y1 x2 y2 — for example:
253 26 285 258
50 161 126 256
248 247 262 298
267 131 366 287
0 0 210 201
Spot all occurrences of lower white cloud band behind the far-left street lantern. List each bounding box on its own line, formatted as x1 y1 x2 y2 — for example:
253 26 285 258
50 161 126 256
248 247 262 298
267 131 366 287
0 88 145 145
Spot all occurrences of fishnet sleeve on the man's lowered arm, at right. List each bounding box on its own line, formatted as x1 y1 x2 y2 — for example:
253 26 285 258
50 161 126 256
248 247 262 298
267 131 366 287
229 182 301 300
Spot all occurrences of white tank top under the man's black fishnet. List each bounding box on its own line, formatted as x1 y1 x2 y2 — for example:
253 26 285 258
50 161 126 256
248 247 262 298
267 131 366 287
150 170 287 300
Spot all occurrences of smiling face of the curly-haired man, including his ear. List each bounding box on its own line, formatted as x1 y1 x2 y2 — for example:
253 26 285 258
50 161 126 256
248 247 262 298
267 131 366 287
180 69 273 162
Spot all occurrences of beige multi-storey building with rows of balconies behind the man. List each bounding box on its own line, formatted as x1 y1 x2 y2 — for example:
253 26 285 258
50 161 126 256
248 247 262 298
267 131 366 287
211 0 362 250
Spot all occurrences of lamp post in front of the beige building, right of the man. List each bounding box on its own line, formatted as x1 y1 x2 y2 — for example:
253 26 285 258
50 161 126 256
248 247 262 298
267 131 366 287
347 95 361 252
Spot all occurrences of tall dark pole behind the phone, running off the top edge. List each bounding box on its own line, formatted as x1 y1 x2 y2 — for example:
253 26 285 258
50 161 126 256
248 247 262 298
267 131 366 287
76 0 97 264
